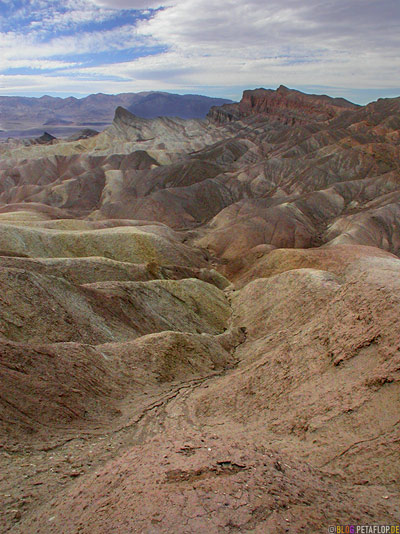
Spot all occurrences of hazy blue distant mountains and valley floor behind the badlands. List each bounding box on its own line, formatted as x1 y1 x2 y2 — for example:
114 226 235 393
0 92 231 137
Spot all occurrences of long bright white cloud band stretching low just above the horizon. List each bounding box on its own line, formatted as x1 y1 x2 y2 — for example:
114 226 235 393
72 47 399 89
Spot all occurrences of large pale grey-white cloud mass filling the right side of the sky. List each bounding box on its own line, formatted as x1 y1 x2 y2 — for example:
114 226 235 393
132 0 400 87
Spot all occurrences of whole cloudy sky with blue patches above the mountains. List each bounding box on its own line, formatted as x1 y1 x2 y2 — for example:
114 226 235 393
0 0 400 104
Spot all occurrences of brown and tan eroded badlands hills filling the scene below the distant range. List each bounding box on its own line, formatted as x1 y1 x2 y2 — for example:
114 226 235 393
0 87 400 534
